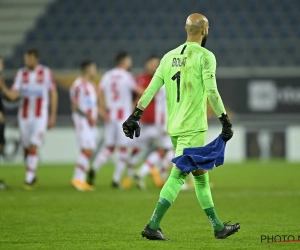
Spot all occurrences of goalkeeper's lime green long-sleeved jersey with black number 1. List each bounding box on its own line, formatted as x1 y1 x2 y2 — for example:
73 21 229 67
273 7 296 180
139 42 225 136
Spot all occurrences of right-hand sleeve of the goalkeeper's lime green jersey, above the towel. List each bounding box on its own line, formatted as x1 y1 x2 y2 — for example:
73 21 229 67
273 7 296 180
201 52 226 117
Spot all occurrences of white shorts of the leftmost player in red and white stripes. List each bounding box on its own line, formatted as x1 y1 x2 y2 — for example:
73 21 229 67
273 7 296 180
19 117 48 148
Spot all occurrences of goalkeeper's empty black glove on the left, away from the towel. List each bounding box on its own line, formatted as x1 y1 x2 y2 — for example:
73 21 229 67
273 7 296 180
122 107 143 139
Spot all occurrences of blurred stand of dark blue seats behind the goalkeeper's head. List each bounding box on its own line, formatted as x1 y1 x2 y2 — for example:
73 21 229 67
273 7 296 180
2 0 300 69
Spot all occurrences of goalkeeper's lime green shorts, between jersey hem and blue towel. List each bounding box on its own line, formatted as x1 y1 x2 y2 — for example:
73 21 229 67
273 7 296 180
171 131 206 157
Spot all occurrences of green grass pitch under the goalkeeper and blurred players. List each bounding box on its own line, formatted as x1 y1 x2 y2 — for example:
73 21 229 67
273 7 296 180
0 162 300 250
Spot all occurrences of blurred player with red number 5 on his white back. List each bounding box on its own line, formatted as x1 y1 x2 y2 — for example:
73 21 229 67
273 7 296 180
88 52 143 187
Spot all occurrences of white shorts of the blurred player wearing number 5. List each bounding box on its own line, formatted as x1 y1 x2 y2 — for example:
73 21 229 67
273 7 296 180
104 121 130 147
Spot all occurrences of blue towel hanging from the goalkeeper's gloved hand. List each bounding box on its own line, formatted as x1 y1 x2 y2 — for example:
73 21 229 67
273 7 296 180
172 135 226 173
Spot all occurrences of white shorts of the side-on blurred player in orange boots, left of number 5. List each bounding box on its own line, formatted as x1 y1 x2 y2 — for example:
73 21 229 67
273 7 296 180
73 118 98 150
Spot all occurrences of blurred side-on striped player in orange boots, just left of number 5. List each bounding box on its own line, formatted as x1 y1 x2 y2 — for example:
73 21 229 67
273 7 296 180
70 61 98 191
